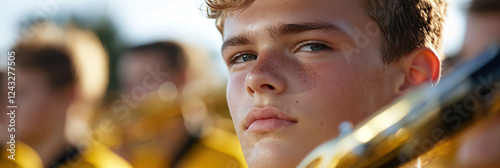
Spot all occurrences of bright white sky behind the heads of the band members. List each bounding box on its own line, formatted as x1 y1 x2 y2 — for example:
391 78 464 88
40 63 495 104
0 0 470 71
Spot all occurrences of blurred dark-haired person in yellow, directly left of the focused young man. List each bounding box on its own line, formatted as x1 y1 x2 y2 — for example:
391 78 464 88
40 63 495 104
95 41 245 168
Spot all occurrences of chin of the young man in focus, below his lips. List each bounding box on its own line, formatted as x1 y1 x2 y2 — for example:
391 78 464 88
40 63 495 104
244 139 314 168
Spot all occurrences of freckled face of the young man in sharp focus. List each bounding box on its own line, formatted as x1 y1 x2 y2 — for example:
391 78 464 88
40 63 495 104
222 0 397 167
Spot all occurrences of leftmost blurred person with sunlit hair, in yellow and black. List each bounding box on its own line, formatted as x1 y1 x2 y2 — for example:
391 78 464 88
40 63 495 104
0 22 131 168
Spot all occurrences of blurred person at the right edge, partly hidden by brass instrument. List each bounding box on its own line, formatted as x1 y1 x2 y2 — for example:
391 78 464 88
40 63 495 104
454 0 500 167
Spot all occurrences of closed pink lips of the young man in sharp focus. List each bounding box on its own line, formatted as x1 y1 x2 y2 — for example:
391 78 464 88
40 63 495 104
245 107 297 133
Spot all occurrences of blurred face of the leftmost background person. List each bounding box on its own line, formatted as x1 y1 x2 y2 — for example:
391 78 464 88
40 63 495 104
16 68 73 143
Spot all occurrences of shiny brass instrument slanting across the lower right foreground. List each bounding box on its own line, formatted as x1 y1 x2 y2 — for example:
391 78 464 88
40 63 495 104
298 47 500 168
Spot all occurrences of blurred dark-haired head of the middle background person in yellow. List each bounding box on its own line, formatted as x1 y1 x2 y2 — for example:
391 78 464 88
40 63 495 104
118 42 186 96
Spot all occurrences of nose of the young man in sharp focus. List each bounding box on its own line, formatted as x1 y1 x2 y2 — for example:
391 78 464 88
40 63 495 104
245 53 287 97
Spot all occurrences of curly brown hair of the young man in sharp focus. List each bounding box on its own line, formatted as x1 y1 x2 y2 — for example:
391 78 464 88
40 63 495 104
205 0 447 63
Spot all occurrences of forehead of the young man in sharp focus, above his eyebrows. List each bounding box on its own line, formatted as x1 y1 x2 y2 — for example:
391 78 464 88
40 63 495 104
224 0 371 39
